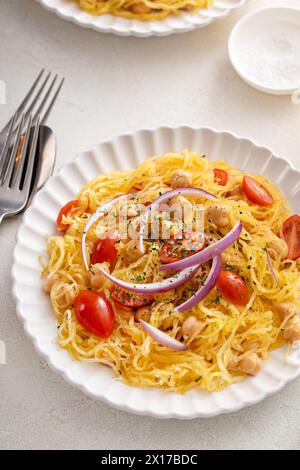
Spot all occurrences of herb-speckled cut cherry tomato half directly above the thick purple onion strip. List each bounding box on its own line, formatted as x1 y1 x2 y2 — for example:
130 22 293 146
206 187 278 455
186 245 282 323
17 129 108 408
160 232 205 264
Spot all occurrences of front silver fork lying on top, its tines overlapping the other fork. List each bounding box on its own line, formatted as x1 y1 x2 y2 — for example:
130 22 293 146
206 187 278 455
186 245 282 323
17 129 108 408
0 113 40 223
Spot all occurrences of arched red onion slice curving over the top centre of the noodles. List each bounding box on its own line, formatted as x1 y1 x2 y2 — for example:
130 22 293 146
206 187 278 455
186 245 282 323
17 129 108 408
139 187 217 253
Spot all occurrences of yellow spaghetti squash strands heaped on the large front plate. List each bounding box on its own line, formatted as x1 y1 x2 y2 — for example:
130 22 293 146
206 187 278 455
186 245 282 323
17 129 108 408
42 151 299 393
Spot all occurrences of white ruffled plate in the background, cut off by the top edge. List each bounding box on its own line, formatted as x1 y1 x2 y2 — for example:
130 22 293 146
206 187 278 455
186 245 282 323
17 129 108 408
37 0 247 37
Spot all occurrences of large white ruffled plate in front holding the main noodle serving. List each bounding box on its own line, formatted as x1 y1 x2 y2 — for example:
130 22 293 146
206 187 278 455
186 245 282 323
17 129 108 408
12 127 300 418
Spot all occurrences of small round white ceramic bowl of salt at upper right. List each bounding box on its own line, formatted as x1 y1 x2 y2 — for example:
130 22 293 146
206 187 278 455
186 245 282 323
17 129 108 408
228 7 300 95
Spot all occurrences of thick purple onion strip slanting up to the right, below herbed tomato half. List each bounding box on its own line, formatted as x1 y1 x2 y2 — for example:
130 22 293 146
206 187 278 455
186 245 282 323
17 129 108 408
159 222 243 271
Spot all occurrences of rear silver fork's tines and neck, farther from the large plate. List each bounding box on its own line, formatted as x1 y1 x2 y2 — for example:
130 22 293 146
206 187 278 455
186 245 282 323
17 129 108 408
0 69 65 154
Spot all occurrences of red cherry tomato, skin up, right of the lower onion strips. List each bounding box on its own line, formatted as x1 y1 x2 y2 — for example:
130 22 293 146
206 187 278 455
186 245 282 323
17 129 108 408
217 271 249 305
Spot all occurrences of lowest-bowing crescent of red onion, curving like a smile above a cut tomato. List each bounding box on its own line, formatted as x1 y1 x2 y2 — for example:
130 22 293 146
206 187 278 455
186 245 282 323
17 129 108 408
92 266 199 294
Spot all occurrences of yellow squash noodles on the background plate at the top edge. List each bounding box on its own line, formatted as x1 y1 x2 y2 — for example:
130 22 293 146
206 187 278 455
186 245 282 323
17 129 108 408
75 0 213 21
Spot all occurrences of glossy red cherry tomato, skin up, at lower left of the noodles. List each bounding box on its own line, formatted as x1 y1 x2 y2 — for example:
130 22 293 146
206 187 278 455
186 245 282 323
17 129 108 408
74 290 116 339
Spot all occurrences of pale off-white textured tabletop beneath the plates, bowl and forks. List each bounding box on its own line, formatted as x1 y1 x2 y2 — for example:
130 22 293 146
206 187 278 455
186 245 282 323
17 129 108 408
0 0 300 449
